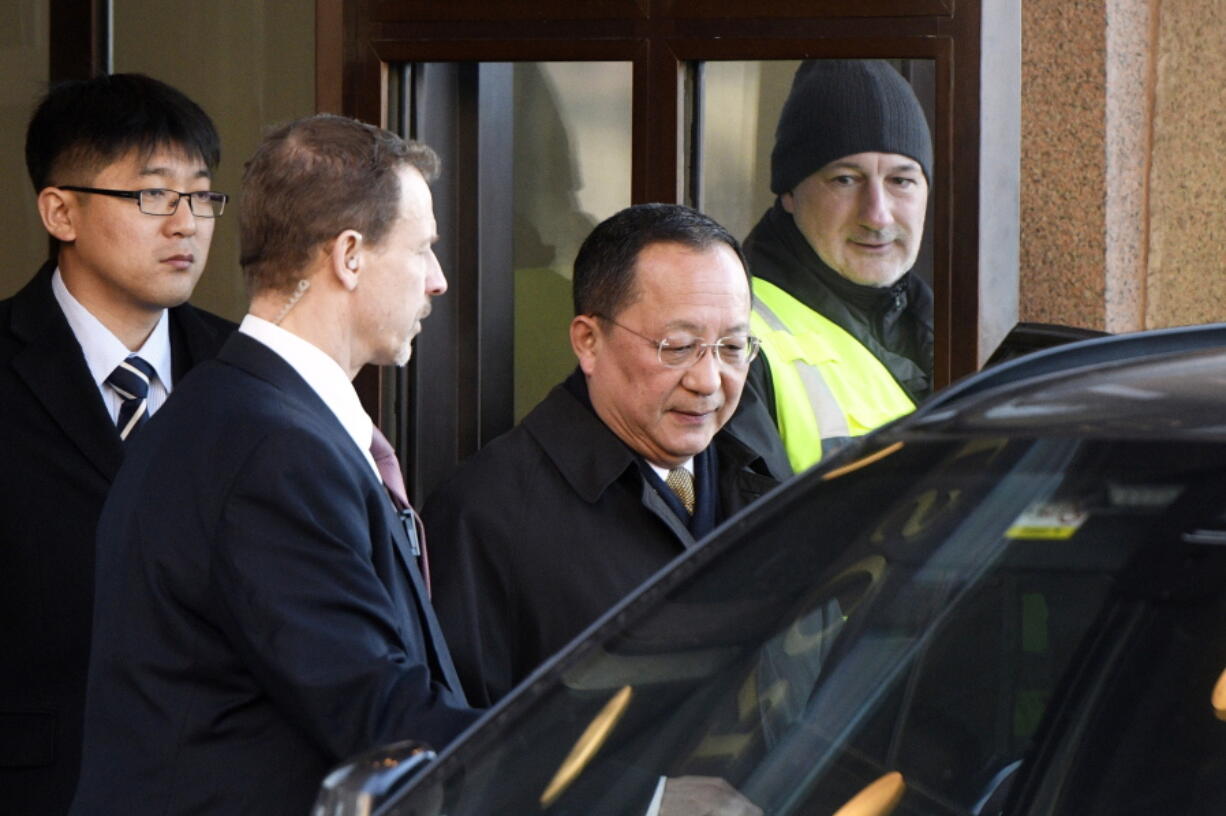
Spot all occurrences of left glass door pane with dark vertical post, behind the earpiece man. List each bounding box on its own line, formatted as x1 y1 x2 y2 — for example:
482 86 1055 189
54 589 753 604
387 61 634 501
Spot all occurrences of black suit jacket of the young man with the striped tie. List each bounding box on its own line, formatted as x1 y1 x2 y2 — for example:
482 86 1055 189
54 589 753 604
0 263 234 815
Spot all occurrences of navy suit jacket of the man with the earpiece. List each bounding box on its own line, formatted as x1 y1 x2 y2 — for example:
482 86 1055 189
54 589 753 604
72 333 477 816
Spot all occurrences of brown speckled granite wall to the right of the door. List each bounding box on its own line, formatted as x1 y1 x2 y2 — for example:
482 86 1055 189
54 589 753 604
1020 0 1226 332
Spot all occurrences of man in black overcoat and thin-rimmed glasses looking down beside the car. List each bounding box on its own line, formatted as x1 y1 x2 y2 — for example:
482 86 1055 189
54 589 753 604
423 205 790 706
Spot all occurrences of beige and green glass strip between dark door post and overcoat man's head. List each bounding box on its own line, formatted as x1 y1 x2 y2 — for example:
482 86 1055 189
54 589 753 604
512 62 631 421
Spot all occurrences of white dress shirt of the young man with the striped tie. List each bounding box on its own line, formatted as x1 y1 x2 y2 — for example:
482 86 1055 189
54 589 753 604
51 267 174 421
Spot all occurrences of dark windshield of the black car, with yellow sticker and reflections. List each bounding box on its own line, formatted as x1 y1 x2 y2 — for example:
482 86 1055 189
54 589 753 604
380 434 1226 815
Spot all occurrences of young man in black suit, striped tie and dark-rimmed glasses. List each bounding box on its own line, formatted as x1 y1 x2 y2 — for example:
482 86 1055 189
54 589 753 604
0 75 233 815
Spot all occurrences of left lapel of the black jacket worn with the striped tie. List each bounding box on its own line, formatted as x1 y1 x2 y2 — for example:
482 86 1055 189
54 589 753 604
12 263 124 482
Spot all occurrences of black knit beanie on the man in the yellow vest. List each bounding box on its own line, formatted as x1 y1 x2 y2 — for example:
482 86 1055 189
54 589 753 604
770 60 932 195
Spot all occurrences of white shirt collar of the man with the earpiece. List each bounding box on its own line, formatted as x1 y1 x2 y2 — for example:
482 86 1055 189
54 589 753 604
238 315 379 475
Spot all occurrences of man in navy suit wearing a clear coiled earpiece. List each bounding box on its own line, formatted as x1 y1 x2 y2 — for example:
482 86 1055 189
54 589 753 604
74 115 477 816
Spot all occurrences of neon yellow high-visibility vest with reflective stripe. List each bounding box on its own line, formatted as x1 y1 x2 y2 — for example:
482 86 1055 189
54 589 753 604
749 278 915 473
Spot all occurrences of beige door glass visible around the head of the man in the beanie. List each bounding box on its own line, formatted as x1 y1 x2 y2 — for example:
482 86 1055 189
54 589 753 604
685 60 935 284
